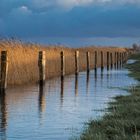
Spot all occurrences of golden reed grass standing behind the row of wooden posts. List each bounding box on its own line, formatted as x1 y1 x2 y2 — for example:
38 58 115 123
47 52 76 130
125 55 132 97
0 40 126 85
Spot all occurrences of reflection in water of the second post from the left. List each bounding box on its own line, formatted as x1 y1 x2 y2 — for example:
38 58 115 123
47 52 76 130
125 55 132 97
38 84 46 118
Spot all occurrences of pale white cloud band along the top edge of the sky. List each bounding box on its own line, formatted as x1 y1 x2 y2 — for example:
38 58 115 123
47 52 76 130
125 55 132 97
29 0 140 8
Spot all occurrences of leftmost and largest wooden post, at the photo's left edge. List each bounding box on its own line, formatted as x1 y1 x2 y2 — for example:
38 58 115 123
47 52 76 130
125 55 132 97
0 51 8 93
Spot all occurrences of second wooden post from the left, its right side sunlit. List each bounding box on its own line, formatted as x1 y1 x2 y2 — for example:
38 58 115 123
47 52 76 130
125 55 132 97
38 51 46 85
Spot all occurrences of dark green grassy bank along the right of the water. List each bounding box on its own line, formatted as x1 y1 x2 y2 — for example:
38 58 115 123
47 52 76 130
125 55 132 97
79 54 140 140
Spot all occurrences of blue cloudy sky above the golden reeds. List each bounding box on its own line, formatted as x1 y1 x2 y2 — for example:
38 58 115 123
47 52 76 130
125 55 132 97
0 0 140 45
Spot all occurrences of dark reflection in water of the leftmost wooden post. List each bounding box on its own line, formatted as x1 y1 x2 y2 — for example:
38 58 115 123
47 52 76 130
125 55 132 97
0 93 7 140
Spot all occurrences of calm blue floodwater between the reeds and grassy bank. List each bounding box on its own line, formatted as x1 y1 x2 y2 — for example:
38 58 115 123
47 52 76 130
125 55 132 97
0 61 137 140
